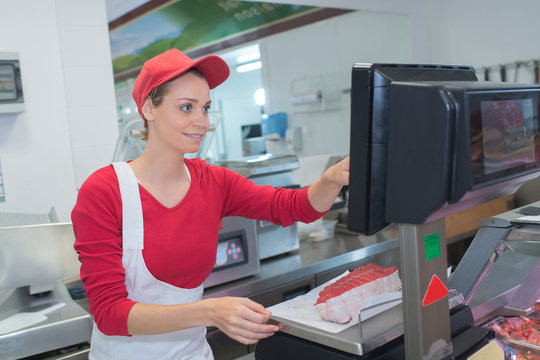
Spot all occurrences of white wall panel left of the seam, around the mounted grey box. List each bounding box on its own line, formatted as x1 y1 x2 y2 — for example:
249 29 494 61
0 0 75 217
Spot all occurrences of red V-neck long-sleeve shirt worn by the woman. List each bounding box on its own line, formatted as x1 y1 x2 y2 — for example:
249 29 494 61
71 159 323 335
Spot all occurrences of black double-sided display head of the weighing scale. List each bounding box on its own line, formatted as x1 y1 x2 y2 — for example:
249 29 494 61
348 64 540 235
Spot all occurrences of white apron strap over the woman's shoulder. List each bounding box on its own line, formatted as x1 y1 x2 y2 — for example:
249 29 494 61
112 161 144 250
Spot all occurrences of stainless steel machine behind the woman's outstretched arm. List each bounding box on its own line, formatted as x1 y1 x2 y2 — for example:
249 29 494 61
217 154 300 260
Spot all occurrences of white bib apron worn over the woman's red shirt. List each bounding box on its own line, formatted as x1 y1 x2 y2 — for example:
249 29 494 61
89 162 214 360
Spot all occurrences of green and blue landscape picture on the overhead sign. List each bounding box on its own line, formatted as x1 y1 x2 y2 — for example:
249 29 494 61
110 0 319 75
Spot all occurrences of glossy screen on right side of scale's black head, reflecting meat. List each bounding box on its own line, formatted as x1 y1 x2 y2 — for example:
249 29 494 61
471 93 540 184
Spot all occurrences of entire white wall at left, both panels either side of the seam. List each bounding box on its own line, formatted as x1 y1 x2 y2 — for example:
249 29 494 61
0 0 117 221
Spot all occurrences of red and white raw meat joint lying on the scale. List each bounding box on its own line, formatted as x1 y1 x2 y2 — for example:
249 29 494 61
315 263 401 324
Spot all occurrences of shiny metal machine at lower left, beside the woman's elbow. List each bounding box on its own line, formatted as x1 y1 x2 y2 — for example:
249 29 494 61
0 223 92 360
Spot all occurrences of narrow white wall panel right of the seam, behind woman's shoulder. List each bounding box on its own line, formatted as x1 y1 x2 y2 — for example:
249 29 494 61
57 0 118 188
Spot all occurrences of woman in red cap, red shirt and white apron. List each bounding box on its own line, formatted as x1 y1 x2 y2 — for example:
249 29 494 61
72 49 349 360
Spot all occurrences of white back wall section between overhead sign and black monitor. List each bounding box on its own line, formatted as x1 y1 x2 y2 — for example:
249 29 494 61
261 12 412 156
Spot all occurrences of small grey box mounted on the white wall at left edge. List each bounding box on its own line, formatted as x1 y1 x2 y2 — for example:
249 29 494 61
0 51 24 113
